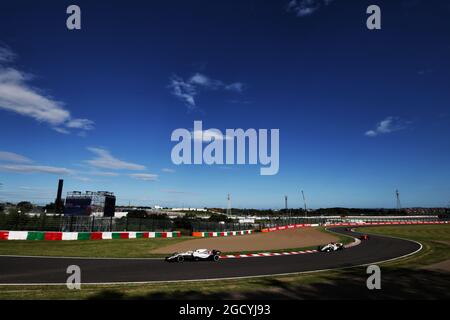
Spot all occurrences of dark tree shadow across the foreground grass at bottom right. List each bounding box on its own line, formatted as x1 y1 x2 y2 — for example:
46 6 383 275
90 268 450 300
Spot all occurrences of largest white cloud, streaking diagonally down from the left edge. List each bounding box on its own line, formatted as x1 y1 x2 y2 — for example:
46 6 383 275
0 47 94 134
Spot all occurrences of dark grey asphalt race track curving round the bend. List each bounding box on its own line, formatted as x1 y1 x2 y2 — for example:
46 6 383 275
0 227 421 285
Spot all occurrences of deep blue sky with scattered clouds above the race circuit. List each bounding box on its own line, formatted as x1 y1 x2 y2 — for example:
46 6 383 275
0 0 450 208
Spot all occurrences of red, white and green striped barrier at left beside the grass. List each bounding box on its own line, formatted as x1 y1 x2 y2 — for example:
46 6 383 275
0 231 181 241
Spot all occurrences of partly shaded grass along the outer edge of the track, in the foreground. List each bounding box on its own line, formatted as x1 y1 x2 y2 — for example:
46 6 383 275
0 226 450 299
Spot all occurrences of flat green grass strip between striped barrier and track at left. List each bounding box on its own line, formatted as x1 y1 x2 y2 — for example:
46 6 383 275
0 237 192 258
